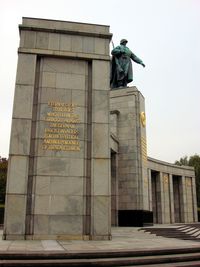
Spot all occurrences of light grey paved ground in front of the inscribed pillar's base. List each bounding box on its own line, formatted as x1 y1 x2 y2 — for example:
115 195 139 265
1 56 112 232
0 225 200 252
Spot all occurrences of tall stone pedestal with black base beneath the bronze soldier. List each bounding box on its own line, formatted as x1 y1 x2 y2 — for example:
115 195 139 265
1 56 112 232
110 87 153 226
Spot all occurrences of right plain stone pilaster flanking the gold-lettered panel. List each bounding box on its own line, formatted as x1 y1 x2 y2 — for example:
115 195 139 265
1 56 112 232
91 60 111 240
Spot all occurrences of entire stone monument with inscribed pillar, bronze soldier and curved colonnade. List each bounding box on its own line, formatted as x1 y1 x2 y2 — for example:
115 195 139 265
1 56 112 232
3 18 197 243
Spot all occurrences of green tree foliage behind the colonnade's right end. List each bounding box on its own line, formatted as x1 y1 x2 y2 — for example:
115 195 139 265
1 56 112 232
175 154 200 207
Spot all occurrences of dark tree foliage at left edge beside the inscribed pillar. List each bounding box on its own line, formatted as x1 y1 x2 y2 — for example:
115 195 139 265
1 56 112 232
0 157 8 204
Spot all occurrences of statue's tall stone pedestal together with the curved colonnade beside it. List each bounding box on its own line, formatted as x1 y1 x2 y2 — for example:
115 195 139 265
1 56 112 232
110 87 197 226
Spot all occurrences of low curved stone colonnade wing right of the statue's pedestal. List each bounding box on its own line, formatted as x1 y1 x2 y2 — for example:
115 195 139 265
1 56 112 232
148 158 198 223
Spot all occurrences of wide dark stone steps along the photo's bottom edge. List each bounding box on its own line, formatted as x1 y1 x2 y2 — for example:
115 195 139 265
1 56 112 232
0 248 200 267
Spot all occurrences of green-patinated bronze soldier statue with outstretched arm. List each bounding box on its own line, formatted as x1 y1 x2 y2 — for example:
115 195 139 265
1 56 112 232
110 39 145 88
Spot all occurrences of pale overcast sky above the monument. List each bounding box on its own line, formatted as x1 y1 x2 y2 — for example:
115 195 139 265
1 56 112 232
0 0 200 163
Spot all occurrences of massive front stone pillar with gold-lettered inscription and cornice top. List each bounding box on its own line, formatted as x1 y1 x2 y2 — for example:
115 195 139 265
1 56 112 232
4 18 112 242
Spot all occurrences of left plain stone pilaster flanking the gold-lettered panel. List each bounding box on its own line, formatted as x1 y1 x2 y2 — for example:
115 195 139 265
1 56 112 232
4 53 36 239
